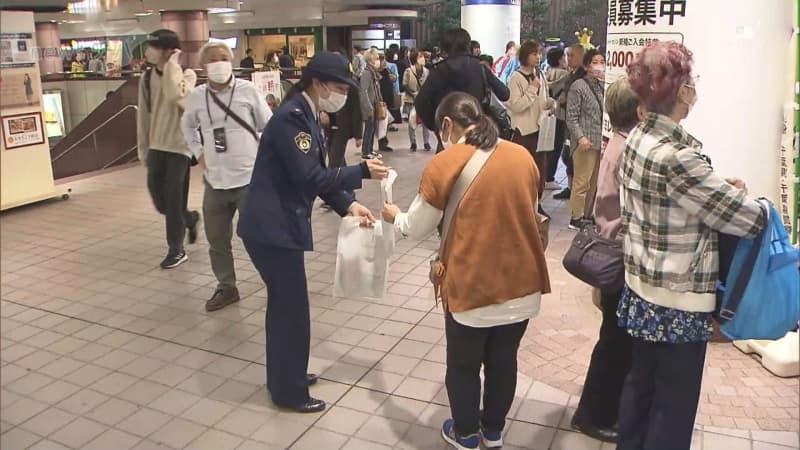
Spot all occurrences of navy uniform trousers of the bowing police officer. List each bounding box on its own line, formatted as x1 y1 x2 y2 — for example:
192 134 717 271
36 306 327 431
244 241 311 407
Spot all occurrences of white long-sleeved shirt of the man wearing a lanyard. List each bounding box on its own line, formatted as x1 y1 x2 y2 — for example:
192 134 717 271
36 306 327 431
181 78 272 189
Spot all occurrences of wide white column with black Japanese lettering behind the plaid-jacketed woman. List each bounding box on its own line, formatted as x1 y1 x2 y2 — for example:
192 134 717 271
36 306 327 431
604 0 797 225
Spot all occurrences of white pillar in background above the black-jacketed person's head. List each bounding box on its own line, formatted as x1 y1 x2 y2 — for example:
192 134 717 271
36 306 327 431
461 0 521 59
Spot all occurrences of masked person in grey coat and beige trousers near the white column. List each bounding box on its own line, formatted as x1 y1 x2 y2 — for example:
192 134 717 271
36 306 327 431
567 50 606 230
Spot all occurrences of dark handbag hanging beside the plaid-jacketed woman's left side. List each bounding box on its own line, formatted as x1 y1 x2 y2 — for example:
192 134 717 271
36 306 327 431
563 226 625 292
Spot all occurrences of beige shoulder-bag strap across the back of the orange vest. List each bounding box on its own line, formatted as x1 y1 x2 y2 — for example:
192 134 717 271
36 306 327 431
429 146 497 305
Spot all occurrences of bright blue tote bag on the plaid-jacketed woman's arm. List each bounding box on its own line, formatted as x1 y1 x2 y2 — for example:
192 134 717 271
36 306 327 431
717 201 800 340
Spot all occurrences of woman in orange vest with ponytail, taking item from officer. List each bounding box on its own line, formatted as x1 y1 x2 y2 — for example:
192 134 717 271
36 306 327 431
383 92 550 450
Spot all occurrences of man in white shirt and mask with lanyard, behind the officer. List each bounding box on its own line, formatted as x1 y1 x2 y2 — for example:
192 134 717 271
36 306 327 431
181 42 272 311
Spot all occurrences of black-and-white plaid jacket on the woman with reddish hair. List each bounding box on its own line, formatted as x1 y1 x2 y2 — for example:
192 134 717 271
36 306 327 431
620 113 766 294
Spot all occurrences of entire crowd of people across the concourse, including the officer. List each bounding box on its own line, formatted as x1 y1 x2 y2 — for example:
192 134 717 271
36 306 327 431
138 29 766 450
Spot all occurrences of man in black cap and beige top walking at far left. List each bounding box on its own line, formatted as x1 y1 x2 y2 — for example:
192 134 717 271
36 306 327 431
137 30 200 269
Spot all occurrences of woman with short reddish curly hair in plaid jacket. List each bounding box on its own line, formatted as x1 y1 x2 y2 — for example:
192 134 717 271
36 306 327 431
617 42 766 450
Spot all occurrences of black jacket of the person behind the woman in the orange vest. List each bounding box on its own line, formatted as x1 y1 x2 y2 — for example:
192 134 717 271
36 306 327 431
415 55 510 131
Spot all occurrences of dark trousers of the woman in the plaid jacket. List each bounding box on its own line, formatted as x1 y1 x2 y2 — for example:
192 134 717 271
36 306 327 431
617 340 707 450
